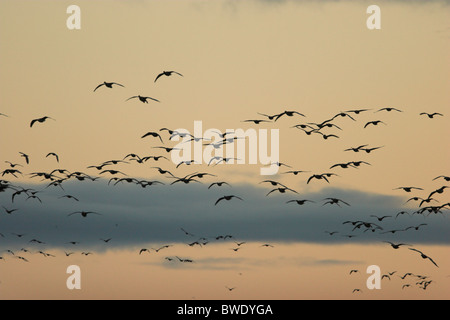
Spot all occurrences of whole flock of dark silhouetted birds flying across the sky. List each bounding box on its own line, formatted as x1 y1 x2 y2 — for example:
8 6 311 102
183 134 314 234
0 71 450 298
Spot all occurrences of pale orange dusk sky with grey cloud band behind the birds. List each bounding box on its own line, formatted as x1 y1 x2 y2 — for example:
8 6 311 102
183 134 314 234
0 0 450 300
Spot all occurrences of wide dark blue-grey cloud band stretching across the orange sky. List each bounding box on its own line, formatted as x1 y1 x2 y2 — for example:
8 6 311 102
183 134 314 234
0 181 450 251
